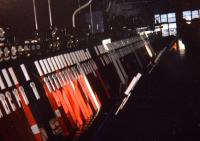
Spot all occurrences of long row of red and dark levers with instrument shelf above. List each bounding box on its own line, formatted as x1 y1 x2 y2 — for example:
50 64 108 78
0 0 175 141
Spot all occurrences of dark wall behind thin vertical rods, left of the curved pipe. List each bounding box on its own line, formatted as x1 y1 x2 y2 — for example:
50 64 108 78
0 0 81 37
